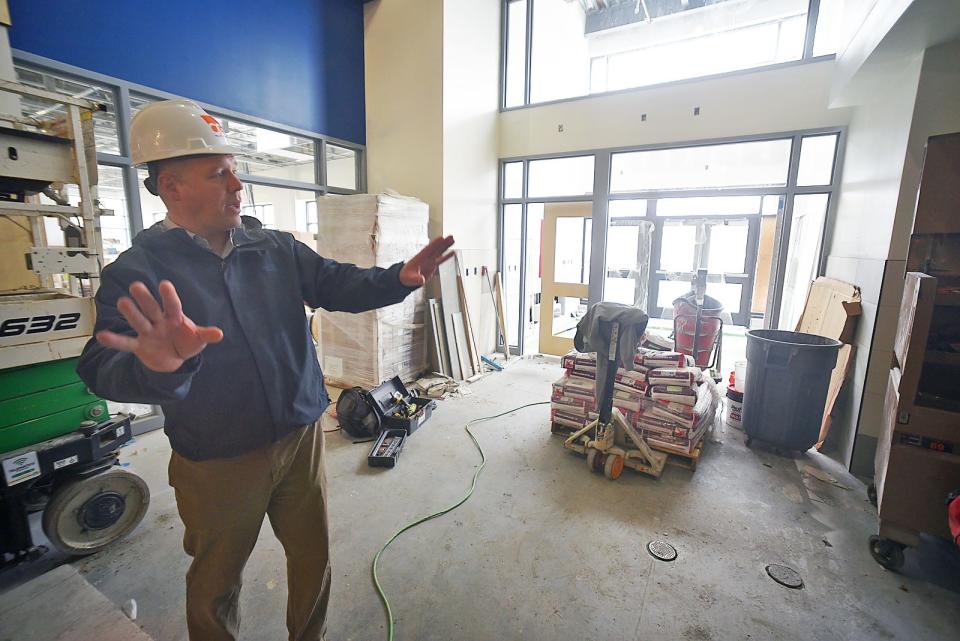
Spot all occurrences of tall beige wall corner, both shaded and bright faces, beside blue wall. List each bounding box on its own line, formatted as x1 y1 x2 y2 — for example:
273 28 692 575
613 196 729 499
364 0 500 353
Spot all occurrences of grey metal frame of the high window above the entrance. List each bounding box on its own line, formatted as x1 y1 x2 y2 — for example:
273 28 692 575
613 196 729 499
499 0 837 112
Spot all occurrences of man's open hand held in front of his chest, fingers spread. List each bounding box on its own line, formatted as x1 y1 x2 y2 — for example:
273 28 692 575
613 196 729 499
97 282 225 372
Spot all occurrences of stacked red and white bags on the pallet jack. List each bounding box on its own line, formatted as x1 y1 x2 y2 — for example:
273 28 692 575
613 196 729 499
550 338 720 459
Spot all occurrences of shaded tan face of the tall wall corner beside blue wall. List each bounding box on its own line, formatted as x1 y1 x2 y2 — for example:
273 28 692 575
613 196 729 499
363 0 443 235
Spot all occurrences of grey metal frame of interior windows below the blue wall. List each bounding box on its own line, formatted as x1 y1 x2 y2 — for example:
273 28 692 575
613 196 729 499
11 48 367 435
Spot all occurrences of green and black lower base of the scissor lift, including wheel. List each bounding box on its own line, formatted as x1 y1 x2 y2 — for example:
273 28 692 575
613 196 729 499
0 358 150 561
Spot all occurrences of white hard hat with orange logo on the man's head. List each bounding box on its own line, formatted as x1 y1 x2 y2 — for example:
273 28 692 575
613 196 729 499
130 100 240 166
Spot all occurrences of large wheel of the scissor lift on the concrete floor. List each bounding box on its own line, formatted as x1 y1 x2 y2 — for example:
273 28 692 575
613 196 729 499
43 468 150 555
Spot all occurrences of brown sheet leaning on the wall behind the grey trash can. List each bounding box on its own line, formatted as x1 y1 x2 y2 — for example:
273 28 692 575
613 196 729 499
797 276 862 449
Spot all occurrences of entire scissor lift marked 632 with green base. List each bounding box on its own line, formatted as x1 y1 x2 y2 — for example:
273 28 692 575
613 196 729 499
0 80 150 565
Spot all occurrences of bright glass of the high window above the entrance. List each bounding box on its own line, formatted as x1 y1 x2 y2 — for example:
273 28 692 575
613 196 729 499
516 0 808 107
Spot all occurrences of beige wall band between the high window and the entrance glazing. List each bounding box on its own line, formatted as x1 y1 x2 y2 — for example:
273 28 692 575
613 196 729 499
500 61 850 158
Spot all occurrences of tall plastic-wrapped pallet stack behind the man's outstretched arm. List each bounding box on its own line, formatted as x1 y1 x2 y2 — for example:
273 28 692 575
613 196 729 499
317 194 429 389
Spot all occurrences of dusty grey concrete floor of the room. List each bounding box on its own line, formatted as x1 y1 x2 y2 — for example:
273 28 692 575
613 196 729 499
0 357 960 641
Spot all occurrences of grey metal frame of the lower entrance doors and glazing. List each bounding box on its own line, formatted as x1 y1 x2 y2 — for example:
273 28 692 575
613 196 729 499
497 125 847 354
